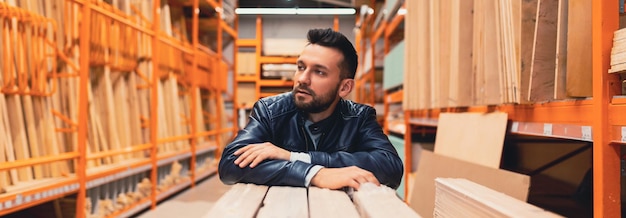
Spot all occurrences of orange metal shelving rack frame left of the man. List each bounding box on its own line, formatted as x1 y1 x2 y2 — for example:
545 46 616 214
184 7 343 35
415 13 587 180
0 0 237 217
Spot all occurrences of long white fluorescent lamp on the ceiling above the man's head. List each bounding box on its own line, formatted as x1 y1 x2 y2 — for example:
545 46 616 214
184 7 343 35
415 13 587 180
235 8 356 15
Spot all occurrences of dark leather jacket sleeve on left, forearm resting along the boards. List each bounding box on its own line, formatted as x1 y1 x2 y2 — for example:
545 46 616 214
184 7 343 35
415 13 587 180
218 101 313 187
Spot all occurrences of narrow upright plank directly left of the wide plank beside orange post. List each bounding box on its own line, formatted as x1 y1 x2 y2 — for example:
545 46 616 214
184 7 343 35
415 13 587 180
554 0 568 99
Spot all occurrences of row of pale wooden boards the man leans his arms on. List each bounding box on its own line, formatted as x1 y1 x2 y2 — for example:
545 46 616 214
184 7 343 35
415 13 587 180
204 183 420 218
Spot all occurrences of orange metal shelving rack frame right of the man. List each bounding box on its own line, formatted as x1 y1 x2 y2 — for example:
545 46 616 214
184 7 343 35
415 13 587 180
356 0 626 217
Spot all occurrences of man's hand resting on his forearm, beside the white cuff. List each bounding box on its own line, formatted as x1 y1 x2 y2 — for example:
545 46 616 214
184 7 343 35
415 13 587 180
233 142 291 168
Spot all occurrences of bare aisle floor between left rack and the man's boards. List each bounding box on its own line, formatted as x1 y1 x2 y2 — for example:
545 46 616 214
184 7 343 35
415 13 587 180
138 174 230 218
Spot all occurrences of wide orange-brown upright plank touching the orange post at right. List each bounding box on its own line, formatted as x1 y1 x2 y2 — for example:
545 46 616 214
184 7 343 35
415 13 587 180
566 0 592 97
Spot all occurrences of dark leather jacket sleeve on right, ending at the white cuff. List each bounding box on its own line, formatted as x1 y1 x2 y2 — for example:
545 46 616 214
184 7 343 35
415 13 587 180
310 107 404 189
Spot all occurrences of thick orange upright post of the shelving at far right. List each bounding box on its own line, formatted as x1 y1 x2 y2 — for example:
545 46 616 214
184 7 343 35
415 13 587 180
591 0 621 217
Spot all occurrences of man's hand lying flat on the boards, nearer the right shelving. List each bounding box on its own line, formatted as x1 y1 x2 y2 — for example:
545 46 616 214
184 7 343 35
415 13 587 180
311 166 380 190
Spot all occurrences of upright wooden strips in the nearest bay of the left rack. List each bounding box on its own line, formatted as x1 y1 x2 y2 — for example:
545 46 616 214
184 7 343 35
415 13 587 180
0 0 71 193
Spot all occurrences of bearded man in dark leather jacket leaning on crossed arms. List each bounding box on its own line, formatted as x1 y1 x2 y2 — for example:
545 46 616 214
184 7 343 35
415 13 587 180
218 29 403 190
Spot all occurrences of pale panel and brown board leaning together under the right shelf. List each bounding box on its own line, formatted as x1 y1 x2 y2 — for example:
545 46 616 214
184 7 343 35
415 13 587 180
408 112 556 215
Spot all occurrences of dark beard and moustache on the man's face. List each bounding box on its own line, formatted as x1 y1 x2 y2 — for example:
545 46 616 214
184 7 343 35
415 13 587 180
291 85 339 114
